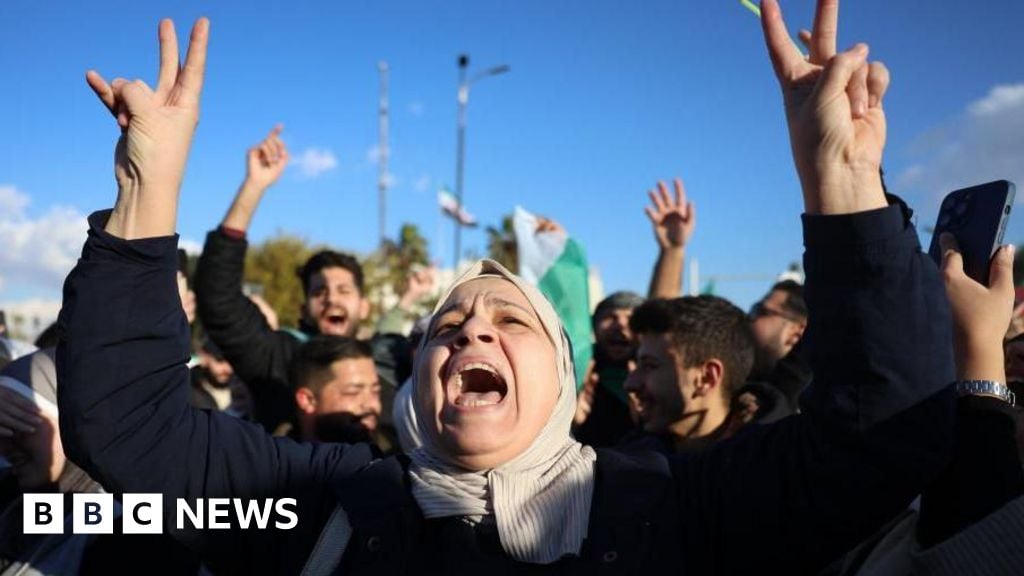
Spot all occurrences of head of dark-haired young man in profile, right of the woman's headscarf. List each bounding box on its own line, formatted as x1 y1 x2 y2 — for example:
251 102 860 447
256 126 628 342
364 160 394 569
626 295 754 452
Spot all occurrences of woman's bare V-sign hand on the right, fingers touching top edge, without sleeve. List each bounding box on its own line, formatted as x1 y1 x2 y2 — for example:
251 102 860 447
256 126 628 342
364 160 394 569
761 0 889 214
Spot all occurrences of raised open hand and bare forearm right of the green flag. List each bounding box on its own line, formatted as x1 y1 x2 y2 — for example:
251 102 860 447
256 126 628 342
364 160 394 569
644 178 697 298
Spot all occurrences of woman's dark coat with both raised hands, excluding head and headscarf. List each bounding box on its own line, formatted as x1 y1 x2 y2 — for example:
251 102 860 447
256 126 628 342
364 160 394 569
57 0 953 575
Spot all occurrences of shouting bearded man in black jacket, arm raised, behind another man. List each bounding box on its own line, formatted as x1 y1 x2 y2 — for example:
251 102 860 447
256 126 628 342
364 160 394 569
196 126 404 433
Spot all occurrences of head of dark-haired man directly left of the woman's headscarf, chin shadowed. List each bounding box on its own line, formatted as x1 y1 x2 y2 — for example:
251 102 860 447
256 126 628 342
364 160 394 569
289 335 391 451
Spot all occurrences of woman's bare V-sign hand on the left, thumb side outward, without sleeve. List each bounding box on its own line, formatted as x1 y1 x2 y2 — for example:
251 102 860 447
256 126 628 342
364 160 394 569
86 18 210 240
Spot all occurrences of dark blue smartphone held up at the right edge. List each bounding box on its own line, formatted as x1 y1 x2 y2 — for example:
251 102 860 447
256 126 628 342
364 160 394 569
928 180 1017 286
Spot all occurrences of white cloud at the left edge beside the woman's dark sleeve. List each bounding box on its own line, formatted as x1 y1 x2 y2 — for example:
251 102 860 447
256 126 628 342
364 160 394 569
0 186 88 290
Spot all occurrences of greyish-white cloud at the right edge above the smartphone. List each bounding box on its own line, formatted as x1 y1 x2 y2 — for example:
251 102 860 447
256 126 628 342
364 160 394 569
892 83 1024 206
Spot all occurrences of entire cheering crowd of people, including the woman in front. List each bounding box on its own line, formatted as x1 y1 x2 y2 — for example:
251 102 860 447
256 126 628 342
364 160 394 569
0 0 1024 576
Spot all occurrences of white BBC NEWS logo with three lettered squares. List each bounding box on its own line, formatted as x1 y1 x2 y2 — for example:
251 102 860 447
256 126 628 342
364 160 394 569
22 494 299 534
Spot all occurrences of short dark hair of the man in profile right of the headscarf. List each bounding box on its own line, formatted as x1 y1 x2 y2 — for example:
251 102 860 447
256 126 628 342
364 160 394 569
630 295 755 398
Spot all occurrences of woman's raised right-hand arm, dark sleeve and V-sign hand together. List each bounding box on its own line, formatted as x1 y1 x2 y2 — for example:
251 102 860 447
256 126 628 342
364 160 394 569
675 0 953 573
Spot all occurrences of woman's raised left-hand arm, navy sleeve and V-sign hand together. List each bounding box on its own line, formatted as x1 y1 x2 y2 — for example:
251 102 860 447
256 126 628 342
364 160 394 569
57 18 358 572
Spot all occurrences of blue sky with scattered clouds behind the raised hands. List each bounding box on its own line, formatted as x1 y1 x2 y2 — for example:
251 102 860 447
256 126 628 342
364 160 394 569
0 0 1024 315
